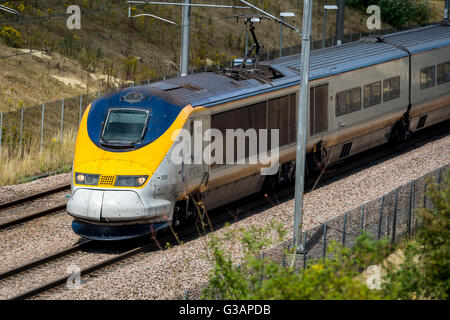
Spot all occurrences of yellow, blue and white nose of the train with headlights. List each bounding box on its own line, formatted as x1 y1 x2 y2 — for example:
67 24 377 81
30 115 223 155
67 86 192 240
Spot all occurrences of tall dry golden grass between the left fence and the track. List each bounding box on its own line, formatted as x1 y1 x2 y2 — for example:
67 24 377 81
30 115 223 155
0 130 76 186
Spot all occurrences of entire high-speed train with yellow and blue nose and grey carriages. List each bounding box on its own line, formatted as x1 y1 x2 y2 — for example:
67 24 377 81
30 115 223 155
67 22 450 240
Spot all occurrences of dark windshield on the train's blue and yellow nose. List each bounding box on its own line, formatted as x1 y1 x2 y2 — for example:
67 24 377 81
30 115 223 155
102 108 149 144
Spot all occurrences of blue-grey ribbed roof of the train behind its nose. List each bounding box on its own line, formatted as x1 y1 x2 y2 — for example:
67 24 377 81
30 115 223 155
150 24 450 107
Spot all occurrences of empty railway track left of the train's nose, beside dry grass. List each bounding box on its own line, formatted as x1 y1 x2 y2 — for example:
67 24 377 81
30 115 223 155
0 184 70 230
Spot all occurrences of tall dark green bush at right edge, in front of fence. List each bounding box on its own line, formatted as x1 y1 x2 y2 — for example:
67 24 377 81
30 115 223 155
383 170 450 299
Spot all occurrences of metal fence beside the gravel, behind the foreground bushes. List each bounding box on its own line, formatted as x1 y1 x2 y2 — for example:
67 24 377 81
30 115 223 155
180 164 450 300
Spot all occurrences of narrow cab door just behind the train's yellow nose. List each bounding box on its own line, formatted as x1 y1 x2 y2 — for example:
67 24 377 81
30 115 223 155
189 115 211 192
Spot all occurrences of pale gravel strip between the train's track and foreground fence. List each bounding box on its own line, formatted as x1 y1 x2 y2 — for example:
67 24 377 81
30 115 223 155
27 132 450 299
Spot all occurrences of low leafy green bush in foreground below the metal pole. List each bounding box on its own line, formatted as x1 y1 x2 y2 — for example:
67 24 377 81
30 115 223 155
203 225 389 300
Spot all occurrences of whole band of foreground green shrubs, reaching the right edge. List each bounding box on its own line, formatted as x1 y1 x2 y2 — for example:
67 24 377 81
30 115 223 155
203 170 450 300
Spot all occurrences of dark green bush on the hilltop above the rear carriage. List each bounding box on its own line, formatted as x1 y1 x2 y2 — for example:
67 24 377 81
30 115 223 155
346 0 431 28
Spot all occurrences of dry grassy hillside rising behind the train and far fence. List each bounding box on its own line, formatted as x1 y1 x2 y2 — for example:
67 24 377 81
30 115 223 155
0 0 442 111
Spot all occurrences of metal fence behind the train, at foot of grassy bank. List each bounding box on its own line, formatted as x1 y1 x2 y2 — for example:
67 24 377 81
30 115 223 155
0 23 440 158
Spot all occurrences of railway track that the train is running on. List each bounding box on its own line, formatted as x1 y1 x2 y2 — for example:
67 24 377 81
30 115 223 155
0 122 450 300
